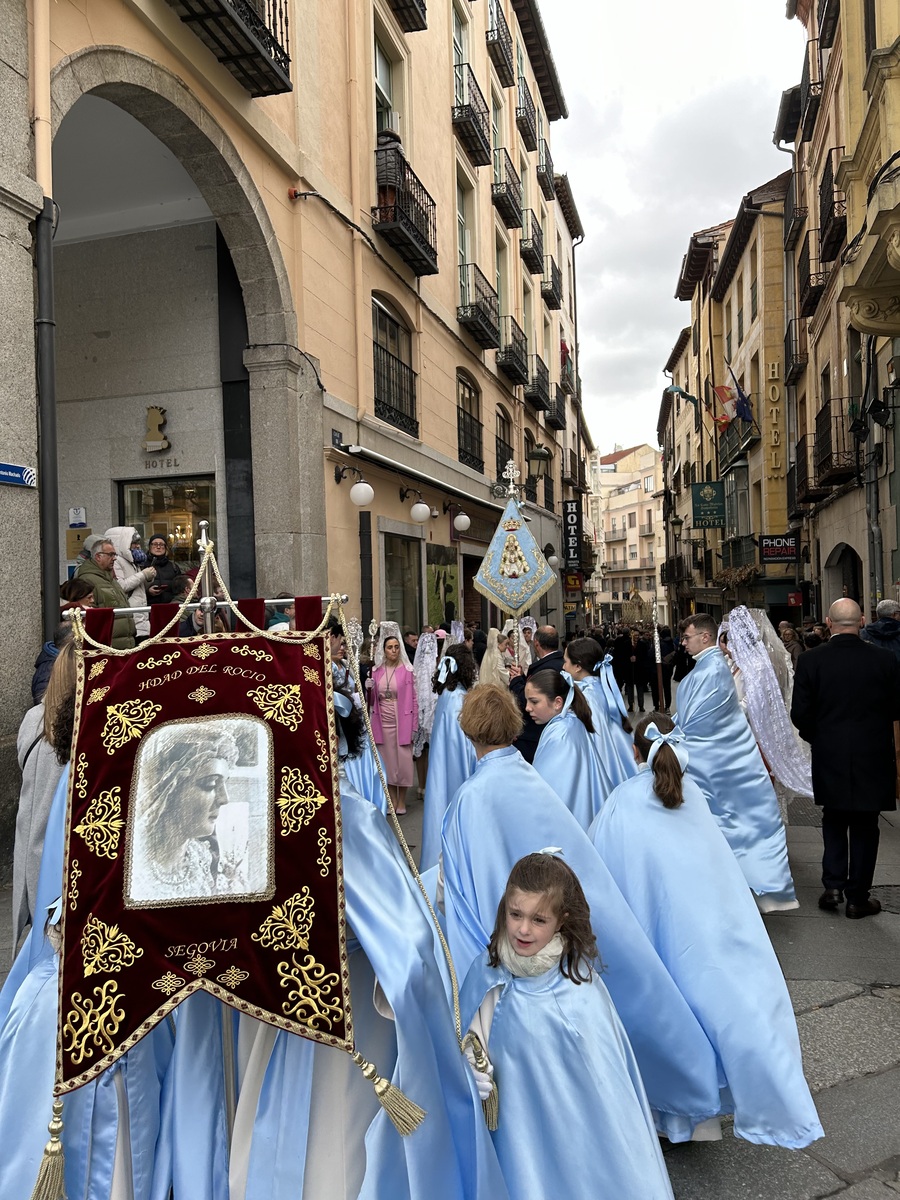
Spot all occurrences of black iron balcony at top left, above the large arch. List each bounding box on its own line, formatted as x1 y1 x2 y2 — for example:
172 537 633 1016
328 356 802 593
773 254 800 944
160 0 293 97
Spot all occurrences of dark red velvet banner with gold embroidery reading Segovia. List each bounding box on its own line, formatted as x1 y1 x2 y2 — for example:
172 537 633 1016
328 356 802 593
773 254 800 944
56 634 353 1092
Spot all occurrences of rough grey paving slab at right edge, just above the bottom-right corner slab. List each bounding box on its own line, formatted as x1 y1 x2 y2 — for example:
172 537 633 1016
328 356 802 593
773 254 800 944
797 996 900 1094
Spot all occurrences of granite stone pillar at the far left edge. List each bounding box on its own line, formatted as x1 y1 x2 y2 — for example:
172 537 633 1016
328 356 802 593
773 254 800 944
0 0 43 883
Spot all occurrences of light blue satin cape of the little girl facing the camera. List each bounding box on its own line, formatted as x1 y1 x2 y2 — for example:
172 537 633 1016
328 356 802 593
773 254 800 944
462 954 672 1200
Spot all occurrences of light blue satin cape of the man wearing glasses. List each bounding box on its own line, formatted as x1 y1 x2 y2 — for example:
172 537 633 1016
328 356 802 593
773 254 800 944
672 649 797 908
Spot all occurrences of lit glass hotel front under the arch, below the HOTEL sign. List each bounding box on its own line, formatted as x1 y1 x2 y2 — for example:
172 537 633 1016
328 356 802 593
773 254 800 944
119 475 216 571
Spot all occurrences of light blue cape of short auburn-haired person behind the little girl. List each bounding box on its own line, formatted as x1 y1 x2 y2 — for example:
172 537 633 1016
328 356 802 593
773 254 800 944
442 736 720 1141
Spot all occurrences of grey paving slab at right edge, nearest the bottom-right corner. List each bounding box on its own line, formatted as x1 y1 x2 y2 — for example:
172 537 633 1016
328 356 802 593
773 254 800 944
815 1070 900 1171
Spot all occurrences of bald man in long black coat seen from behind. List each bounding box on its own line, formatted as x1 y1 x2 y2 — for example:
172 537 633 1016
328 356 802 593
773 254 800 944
791 600 900 918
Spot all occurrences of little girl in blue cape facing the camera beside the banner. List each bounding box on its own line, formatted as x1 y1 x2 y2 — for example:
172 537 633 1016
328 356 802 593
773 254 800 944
462 851 672 1200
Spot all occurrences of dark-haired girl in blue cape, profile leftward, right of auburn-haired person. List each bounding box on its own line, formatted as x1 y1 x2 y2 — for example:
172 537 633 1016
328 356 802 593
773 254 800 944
524 671 608 829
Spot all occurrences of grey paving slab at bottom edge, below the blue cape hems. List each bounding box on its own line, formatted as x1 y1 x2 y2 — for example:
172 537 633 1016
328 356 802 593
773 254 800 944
662 1134 842 1200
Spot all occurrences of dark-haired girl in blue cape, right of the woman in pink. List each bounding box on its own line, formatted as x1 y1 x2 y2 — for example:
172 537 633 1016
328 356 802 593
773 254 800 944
419 643 475 871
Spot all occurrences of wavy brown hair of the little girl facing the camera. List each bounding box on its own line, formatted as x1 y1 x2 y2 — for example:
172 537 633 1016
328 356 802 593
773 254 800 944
487 854 600 983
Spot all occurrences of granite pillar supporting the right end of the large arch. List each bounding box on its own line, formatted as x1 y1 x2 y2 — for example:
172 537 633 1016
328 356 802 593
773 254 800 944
244 344 328 596
